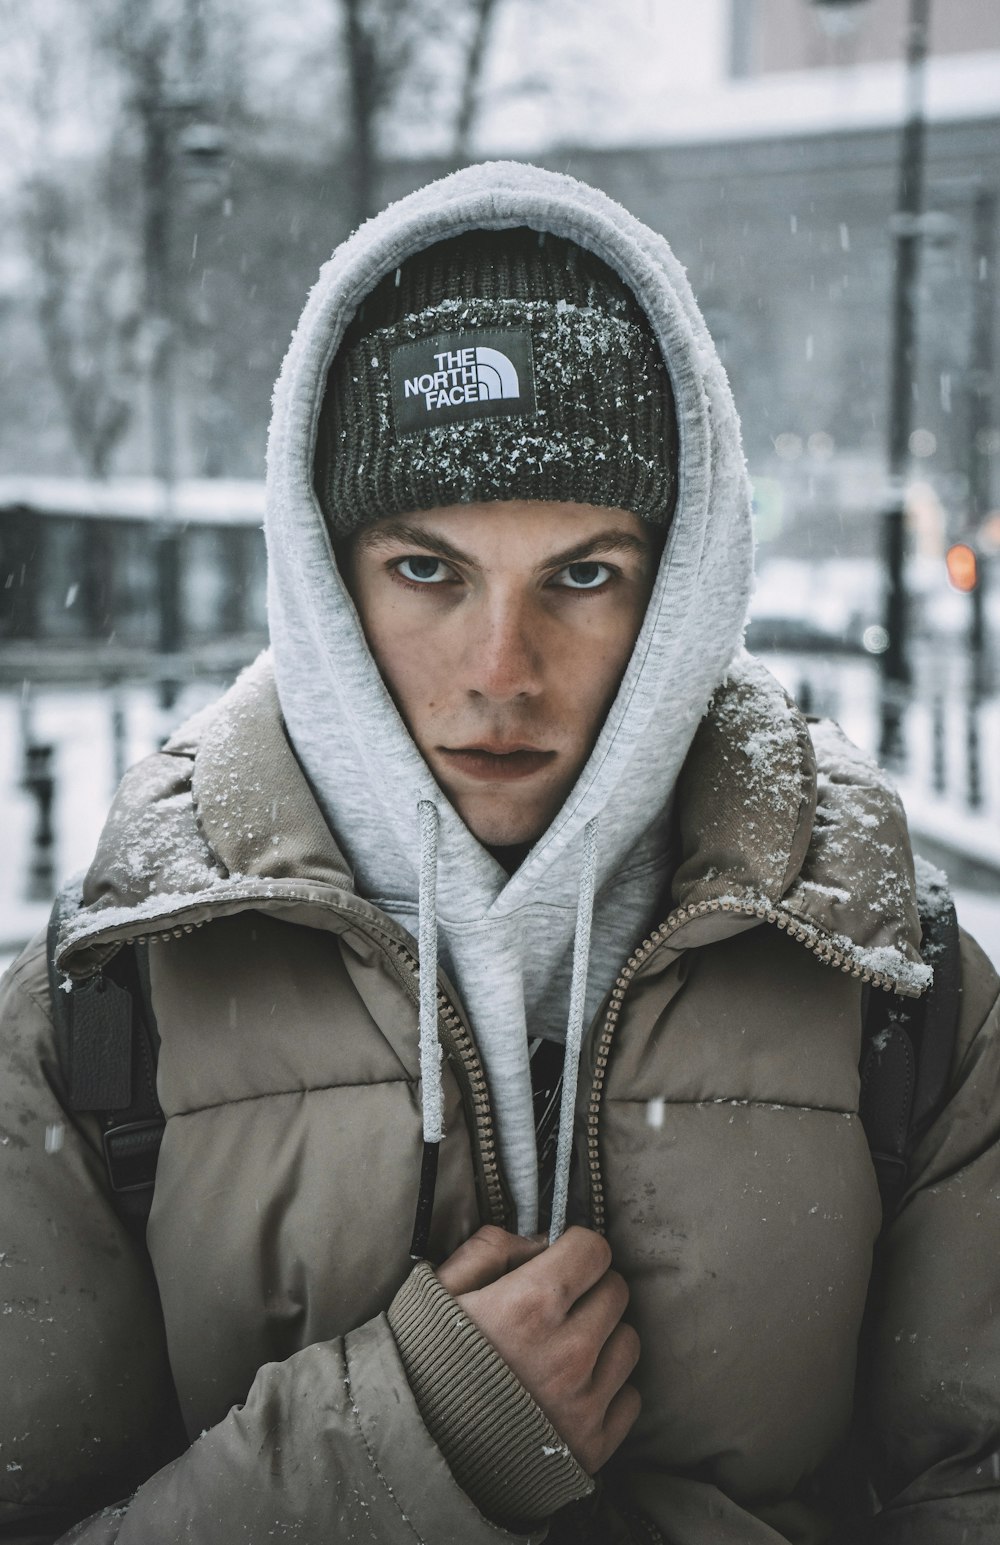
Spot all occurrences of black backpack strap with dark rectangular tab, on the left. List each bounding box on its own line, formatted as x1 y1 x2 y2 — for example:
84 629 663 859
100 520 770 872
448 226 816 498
48 881 165 1239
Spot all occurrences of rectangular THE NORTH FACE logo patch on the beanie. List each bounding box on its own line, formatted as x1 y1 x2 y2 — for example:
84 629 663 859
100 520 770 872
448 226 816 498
389 328 536 434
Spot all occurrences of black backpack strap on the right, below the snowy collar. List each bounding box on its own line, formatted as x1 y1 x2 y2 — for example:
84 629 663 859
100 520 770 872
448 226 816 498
859 859 961 1216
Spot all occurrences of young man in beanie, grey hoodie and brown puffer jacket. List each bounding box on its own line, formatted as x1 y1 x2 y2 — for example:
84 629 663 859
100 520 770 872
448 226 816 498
0 165 1000 1545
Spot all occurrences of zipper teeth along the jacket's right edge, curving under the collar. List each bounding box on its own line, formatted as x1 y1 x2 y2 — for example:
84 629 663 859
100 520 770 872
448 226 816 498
587 901 933 1234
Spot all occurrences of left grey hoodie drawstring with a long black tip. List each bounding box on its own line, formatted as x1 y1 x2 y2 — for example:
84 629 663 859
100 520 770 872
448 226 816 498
410 799 444 1261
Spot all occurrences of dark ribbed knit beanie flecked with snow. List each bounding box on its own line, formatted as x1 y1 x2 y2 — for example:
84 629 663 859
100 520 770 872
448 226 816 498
315 227 677 539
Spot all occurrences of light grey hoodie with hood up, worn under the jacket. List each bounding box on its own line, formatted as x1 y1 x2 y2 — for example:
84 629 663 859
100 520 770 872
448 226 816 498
266 162 751 1231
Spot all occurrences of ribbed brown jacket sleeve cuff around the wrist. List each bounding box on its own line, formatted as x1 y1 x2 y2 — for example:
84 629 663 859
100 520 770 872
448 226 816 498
388 1261 594 1533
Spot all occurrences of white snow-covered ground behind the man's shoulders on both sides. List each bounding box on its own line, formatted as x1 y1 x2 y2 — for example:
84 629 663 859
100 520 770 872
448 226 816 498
0 667 1000 969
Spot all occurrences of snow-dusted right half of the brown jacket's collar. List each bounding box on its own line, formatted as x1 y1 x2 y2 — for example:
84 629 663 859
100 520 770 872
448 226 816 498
669 655 930 997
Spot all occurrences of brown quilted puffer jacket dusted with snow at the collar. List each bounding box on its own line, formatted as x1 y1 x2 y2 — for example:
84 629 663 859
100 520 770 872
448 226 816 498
0 645 1000 1545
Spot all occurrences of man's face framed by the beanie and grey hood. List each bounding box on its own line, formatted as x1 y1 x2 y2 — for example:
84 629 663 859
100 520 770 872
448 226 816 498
345 499 658 848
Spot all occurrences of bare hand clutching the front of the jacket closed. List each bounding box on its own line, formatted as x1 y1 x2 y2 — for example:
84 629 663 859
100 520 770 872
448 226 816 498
437 1227 640 1474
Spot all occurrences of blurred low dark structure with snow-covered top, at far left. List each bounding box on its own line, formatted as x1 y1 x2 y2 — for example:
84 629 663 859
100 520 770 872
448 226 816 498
0 476 266 686
